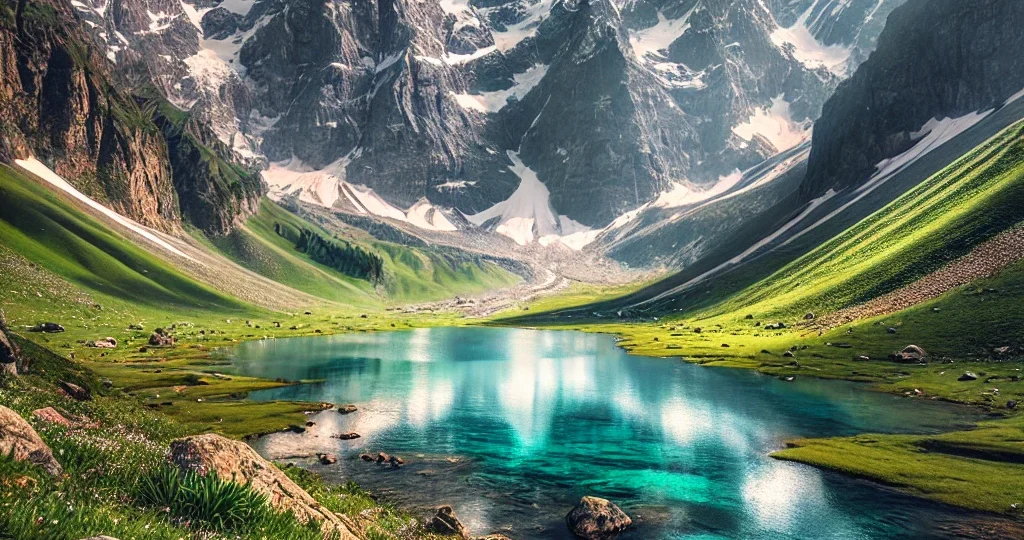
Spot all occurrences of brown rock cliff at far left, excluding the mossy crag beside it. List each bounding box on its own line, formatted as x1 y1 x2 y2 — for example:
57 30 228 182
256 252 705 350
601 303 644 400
0 0 179 230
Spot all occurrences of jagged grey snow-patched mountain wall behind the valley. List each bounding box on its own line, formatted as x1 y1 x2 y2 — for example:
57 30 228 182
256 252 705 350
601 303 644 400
72 0 902 247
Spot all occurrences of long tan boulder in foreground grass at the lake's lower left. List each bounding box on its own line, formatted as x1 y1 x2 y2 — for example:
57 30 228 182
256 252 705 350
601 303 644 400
171 433 356 540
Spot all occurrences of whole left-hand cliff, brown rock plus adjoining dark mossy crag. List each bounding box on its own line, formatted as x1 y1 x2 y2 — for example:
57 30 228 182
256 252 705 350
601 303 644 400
0 0 262 235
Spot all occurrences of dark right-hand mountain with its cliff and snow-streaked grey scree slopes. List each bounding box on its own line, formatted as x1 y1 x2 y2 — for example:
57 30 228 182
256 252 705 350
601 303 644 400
536 0 1024 315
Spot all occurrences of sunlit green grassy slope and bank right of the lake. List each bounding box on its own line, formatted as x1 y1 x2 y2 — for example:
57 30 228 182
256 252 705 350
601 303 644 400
499 124 1024 516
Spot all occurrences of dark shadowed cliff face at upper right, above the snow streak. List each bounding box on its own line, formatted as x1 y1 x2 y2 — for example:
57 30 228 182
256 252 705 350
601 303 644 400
801 0 1024 199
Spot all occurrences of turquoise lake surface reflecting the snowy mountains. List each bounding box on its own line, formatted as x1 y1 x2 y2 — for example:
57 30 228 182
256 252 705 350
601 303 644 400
231 328 977 540
